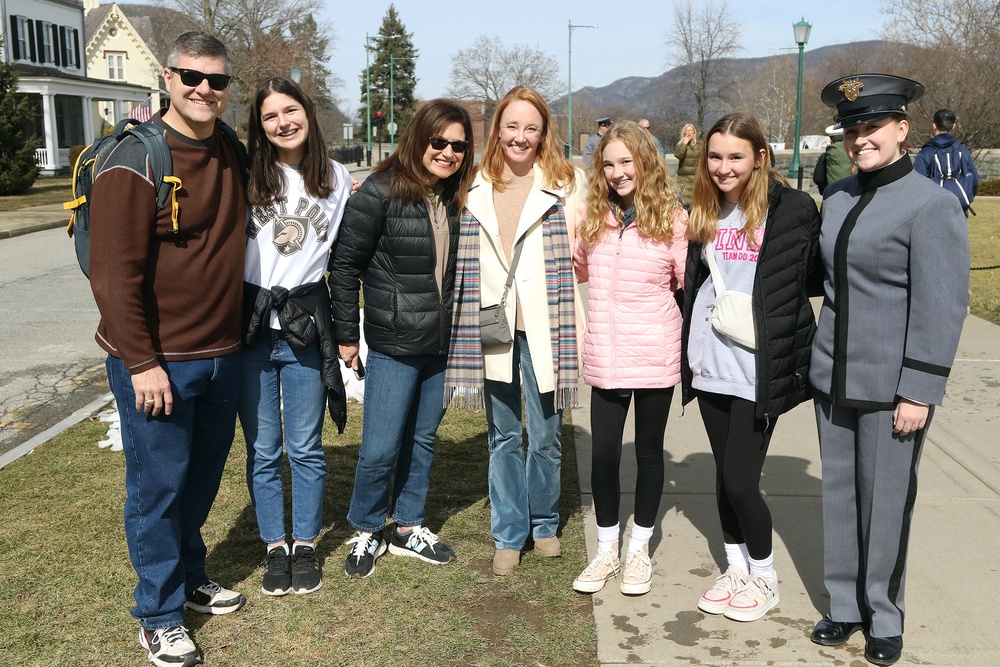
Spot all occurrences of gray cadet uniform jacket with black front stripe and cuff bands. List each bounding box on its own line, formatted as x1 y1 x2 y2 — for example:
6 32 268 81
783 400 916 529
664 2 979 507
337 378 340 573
809 157 969 410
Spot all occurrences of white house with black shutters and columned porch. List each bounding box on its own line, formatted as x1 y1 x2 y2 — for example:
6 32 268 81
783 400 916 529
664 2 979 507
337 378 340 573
0 0 159 174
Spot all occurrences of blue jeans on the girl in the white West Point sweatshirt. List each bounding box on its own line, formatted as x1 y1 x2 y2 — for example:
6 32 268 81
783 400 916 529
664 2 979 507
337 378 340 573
240 330 326 544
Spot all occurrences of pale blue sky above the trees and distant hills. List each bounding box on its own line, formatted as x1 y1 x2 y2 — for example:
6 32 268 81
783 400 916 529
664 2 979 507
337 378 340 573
324 0 882 111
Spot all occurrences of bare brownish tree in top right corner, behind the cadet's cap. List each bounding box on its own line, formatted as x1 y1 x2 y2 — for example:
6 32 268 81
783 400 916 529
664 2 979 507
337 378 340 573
882 0 1000 148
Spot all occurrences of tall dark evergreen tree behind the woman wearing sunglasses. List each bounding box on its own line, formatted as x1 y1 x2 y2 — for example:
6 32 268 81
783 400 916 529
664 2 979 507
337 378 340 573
359 5 418 141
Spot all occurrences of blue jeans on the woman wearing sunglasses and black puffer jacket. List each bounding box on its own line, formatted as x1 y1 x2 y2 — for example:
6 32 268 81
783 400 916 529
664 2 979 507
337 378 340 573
347 349 448 533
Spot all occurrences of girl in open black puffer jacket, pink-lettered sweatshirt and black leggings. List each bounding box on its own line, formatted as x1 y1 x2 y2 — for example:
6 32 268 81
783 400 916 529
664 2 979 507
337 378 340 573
681 113 819 621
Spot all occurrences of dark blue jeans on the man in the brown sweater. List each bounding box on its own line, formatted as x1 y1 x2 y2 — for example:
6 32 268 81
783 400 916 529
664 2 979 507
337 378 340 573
106 352 240 631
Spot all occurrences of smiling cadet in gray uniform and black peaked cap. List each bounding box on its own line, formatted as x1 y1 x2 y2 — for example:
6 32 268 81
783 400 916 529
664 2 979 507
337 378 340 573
809 74 969 665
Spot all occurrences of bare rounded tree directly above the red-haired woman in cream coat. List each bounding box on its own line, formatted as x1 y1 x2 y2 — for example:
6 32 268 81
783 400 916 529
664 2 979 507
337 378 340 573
448 35 561 118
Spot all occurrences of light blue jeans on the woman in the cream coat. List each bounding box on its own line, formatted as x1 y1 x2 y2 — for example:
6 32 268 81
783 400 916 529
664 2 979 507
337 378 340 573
486 331 562 550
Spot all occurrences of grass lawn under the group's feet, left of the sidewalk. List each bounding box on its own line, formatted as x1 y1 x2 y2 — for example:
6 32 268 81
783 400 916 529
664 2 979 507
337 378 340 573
0 403 597 667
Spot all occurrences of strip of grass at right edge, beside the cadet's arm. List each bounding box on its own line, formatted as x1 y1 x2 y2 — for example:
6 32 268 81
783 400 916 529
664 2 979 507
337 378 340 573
969 199 1000 324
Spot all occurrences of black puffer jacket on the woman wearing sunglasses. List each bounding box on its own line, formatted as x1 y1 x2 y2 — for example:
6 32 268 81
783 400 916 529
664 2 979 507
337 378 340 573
329 172 459 356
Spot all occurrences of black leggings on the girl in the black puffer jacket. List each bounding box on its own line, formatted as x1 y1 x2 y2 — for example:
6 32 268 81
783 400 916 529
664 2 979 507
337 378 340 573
698 392 776 560
